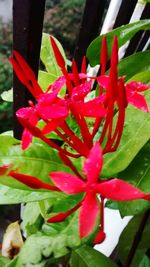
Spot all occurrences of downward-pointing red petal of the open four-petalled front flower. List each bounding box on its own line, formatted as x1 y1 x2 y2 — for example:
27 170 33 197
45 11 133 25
80 193 99 238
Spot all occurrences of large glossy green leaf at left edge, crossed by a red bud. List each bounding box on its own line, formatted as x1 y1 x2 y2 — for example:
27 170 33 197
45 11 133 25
0 136 75 191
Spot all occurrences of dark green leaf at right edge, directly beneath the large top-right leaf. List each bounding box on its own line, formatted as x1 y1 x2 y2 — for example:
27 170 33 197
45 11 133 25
118 50 150 81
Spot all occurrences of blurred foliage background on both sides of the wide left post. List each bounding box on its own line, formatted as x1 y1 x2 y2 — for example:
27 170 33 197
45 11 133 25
0 0 85 133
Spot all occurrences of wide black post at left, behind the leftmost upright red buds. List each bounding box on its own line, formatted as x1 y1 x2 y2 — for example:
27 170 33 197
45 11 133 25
13 0 45 139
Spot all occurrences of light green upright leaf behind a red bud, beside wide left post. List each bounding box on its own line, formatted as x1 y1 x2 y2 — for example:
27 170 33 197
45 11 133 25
40 33 66 76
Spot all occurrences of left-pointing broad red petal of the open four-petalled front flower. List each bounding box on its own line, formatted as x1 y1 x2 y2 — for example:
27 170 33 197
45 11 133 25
50 172 85 194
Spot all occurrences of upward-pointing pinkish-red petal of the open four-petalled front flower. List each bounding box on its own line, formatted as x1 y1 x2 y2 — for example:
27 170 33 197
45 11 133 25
83 142 103 183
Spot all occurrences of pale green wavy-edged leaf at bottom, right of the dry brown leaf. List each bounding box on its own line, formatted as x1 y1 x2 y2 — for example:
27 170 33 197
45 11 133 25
15 213 80 267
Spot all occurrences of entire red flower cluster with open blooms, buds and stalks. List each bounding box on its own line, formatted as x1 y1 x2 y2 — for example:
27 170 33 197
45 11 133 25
1 37 149 243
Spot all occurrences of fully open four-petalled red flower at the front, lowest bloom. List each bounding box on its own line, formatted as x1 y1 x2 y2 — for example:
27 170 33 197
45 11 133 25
48 143 145 238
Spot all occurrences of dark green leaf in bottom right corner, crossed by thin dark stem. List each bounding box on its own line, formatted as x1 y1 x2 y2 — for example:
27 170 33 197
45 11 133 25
118 214 150 267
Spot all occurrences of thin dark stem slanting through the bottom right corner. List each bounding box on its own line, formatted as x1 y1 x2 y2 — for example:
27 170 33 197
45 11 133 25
124 209 150 267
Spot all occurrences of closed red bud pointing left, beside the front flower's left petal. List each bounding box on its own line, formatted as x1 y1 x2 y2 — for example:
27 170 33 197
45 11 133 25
9 171 59 191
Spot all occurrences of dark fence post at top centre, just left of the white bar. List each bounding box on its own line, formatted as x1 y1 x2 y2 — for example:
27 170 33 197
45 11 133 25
74 0 107 69
